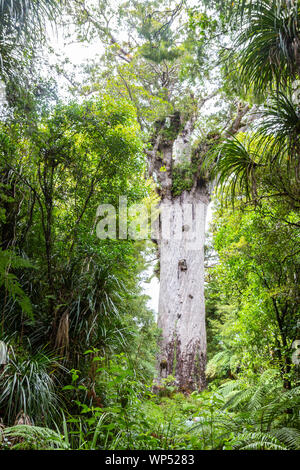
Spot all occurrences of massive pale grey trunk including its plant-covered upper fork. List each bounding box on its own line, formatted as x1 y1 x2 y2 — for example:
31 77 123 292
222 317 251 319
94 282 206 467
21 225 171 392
148 108 209 391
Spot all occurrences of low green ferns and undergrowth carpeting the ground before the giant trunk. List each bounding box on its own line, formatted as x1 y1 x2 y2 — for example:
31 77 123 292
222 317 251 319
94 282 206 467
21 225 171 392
2 370 300 450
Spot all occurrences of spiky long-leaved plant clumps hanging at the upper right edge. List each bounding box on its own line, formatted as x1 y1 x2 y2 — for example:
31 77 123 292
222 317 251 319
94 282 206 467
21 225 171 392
206 0 300 209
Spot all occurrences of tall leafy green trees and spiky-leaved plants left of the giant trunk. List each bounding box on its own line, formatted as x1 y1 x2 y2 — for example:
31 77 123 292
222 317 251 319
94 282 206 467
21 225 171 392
0 89 157 434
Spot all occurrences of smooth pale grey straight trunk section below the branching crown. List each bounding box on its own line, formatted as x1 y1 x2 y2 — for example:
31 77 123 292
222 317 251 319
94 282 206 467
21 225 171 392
158 187 208 390
